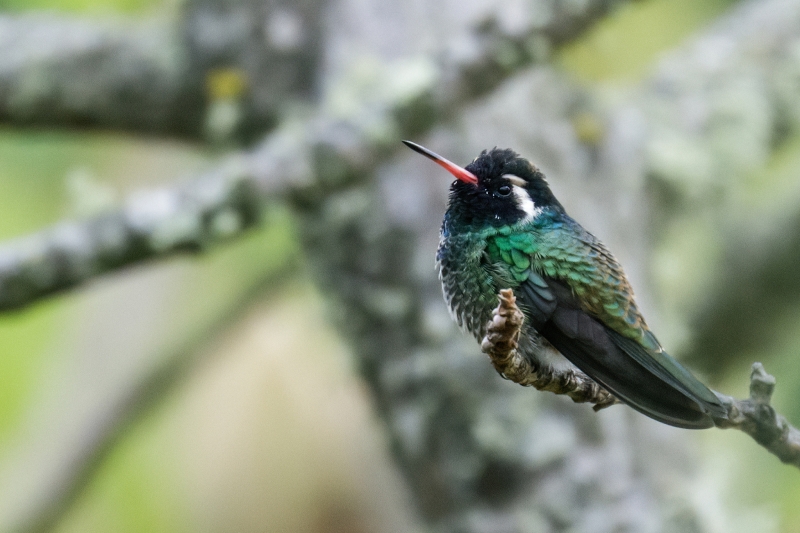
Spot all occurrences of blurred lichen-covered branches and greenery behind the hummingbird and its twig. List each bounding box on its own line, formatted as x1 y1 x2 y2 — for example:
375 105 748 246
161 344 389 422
0 0 800 533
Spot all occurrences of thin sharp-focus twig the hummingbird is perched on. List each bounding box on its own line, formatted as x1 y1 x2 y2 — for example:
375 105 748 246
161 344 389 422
481 289 800 468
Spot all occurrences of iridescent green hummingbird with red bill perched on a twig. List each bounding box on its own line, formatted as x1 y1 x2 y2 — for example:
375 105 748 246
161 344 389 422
403 141 727 429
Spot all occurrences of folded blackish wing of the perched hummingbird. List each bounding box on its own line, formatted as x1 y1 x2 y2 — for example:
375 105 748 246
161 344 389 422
517 273 726 429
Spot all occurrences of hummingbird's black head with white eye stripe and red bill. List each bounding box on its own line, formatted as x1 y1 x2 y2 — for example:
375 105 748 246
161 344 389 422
403 141 564 227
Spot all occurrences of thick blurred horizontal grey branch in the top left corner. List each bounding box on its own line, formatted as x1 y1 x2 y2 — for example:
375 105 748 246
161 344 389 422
0 14 203 135
